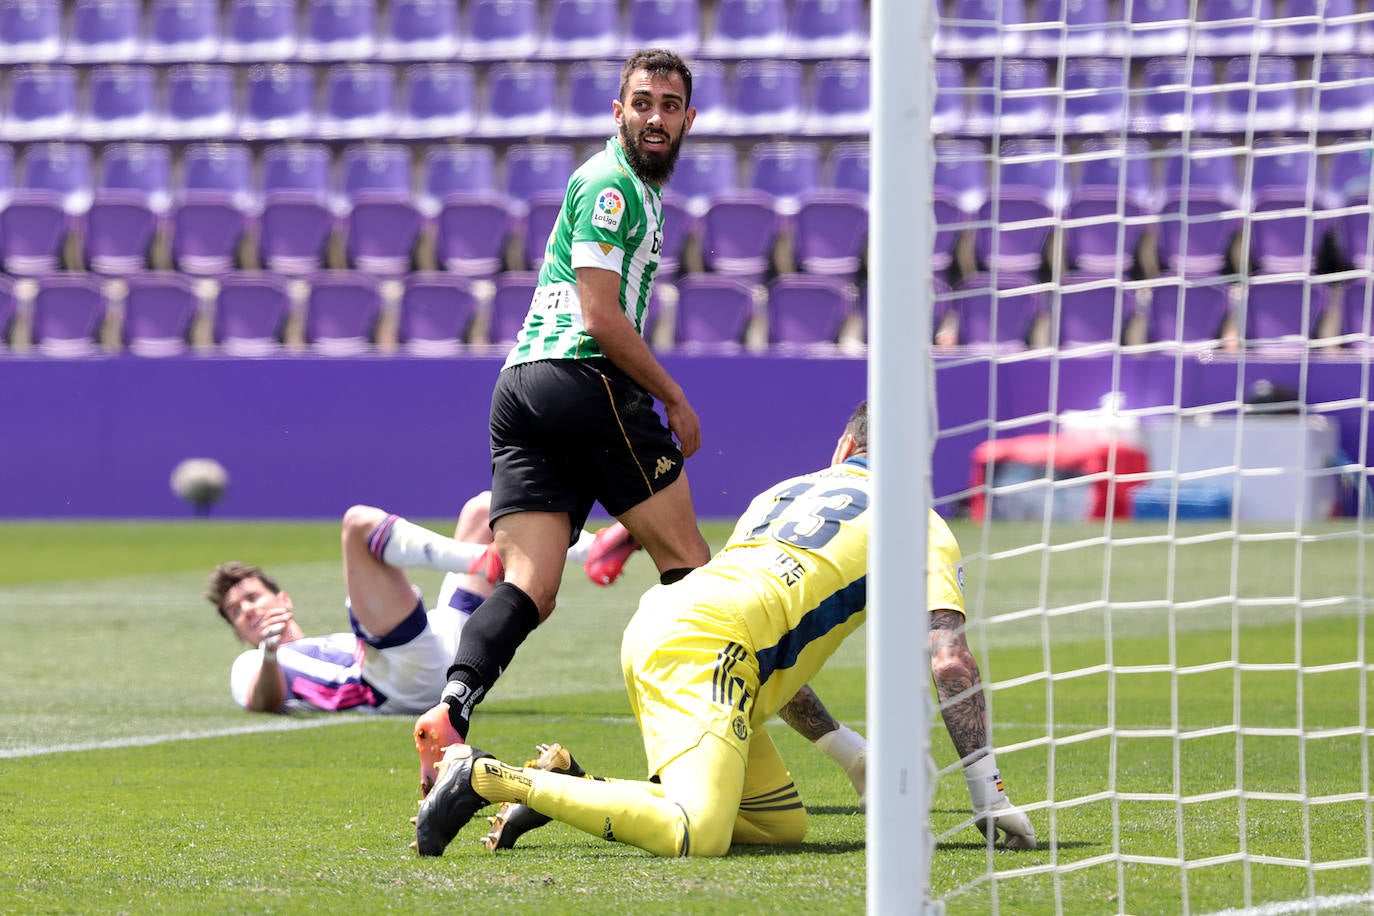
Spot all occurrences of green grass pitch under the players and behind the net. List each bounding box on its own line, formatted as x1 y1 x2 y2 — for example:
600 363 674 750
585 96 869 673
0 522 1374 913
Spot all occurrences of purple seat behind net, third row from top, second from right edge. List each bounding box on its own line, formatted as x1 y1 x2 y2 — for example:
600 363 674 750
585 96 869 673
1250 139 1333 273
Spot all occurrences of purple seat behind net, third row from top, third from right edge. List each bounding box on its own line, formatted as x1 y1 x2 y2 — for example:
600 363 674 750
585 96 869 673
1158 137 1241 276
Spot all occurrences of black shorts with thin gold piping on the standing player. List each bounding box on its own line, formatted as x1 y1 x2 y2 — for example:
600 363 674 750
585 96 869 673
491 358 683 540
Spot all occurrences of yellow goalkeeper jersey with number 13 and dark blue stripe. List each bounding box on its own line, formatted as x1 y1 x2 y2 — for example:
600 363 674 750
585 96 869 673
688 457 965 726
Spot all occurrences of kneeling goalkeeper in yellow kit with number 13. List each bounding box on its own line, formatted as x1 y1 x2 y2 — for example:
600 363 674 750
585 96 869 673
415 405 1036 856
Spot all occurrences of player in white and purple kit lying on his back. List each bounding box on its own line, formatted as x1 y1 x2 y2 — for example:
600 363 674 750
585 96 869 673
206 492 632 715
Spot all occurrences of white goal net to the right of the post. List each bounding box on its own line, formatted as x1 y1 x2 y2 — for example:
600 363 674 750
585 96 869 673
895 0 1374 913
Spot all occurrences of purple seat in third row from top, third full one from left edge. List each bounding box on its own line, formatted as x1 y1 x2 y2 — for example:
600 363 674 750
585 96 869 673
172 143 254 276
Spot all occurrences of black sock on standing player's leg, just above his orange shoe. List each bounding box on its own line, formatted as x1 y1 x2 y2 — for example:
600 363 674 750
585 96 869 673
444 582 539 740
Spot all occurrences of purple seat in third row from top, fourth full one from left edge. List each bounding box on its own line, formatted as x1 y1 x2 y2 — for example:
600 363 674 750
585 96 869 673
258 144 334 275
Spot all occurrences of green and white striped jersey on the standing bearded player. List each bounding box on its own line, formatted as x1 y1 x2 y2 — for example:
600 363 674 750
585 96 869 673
506 137 664 365
